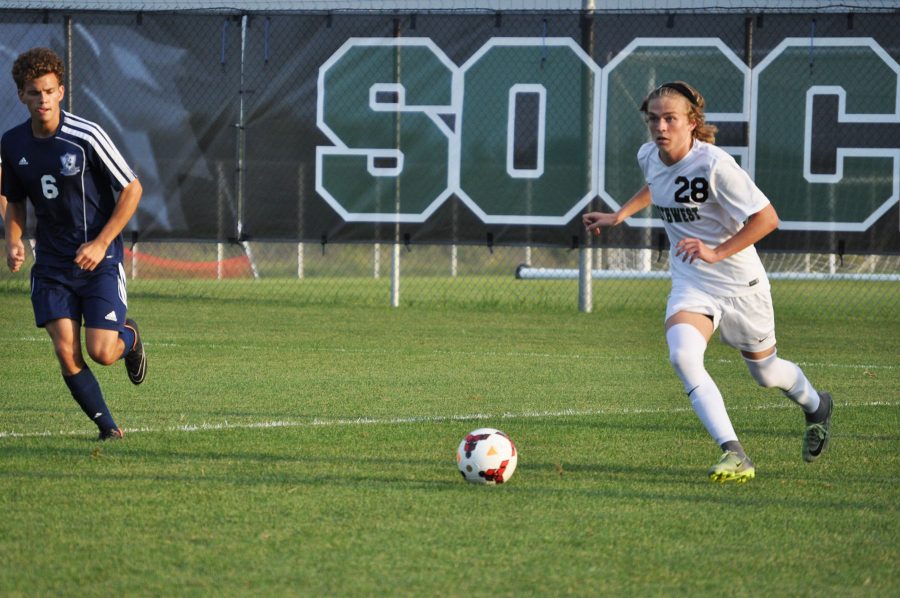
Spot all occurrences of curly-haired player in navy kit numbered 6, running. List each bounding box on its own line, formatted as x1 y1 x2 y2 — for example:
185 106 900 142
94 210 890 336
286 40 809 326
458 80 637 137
0 48 147 440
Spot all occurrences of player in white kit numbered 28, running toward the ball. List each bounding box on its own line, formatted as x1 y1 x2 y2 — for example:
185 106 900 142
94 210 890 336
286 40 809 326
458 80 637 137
583 81 832 482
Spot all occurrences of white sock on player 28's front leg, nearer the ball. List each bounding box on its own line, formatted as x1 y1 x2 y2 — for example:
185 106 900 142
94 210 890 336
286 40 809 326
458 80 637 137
666 324 737 446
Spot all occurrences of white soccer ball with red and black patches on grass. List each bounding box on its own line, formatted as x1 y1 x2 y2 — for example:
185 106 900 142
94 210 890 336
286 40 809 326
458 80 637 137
456 428 519 484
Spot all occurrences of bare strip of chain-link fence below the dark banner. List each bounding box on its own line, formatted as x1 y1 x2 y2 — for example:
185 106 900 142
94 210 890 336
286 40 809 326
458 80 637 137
0 242 900 322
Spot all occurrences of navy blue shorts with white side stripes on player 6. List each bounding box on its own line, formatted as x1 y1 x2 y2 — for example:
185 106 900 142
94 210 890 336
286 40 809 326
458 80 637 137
31 264 128 330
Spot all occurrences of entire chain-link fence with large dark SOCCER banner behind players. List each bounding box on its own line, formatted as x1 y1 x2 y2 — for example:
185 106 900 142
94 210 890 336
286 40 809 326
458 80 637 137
0 9 900 318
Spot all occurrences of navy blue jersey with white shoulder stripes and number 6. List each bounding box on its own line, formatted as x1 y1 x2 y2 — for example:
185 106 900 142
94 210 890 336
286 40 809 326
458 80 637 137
0 111 135 268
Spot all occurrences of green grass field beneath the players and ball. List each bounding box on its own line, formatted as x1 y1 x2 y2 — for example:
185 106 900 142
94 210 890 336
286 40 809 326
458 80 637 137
0 282 900 596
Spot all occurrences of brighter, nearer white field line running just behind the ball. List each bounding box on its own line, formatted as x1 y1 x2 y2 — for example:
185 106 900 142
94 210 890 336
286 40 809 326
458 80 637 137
0 401 900 439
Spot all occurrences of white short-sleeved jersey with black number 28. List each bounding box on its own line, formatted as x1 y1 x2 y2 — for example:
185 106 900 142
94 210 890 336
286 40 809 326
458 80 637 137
638 139 769 297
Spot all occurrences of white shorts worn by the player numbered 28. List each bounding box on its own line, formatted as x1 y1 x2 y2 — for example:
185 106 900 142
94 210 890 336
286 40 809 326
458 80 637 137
666 286 775 353
